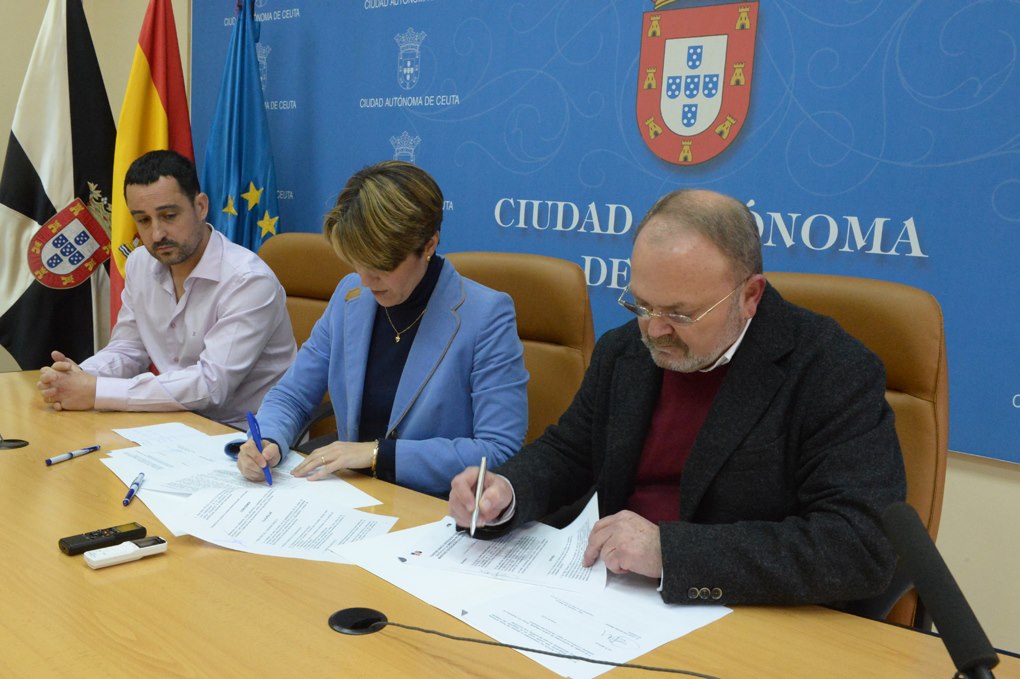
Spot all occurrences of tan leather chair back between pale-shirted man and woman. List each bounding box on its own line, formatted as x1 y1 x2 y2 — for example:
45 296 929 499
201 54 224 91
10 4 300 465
258 233 354 347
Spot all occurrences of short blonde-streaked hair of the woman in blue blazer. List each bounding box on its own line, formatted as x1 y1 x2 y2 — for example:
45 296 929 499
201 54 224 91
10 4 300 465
322 160 443 271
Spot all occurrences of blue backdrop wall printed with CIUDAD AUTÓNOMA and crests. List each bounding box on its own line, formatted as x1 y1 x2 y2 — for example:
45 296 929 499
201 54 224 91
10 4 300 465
192 0 1020 462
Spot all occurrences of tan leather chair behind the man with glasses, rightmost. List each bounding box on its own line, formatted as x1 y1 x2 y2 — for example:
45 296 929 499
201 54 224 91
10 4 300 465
766 272 949 626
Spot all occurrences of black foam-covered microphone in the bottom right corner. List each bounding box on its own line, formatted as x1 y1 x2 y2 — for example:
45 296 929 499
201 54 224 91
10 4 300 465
882 503 999 679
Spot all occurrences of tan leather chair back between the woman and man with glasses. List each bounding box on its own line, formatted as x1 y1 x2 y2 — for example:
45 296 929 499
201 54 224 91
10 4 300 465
446 252 595 442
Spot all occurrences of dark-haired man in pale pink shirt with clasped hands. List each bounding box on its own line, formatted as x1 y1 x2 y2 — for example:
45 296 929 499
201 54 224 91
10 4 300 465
38 151 296 427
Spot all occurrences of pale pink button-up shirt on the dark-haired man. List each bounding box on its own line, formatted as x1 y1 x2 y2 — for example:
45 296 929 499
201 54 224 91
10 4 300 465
82 227 296 429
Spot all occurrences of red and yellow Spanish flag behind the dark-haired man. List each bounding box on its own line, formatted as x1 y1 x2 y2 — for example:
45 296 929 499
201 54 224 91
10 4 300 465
110 0 195 326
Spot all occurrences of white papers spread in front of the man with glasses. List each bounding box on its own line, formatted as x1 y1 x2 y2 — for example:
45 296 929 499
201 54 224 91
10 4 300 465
337 491 730 679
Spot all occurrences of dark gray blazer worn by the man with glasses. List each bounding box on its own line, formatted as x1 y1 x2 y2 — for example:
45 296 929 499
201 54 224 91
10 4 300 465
494 285 906 605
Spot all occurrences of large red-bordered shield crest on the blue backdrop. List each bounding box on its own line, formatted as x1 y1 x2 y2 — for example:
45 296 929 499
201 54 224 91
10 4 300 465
636 0 758 165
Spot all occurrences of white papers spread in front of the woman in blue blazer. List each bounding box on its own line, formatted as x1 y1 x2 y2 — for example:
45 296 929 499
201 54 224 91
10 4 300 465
102 423 397 563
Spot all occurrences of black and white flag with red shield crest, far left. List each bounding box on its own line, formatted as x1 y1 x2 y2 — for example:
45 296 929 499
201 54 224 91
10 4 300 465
0 0 116 370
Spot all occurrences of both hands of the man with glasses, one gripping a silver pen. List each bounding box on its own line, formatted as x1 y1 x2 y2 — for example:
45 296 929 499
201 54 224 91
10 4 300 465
450 467 662 579
